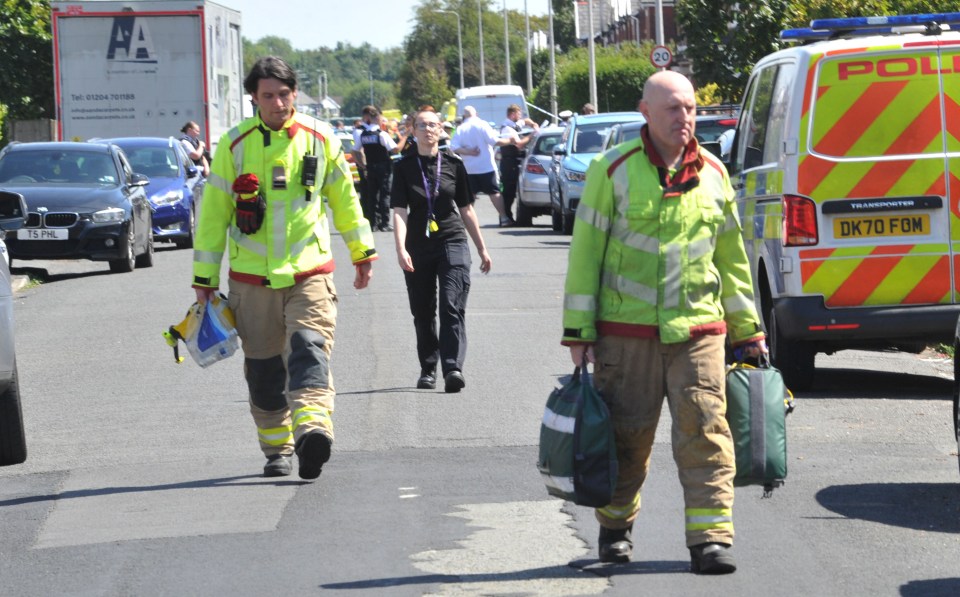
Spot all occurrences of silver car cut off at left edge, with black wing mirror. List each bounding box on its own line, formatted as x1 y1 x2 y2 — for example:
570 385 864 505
0 191 27 466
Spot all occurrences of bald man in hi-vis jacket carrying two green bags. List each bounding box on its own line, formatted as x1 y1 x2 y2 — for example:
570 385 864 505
563 71 766 574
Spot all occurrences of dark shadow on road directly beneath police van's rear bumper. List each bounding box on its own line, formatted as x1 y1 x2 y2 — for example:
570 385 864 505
796 367 953 400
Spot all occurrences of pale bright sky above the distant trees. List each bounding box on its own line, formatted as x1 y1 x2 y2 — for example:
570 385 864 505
215 0 548 50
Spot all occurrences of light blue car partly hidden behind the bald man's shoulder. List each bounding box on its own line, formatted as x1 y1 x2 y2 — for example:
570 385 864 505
550 112 645 234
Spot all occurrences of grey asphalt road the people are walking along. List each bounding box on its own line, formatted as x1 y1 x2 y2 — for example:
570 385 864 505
0 203 960 597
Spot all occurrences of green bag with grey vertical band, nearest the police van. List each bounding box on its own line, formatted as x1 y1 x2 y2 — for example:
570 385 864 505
727 356 794 497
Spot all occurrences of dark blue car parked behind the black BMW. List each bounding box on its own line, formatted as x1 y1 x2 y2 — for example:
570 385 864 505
100 137 206 249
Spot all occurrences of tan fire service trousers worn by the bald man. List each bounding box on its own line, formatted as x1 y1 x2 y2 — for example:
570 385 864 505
594 336 735 547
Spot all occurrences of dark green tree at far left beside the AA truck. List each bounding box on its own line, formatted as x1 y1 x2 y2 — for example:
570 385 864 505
0 0 55 141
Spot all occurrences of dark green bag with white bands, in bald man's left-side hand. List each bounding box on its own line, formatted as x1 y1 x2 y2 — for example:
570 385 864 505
537 362 617 508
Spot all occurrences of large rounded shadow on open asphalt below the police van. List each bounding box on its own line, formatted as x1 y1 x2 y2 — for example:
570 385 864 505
817 483 960 532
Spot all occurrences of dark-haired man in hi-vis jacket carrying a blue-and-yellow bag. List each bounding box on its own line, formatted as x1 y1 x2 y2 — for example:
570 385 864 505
193 56 376 479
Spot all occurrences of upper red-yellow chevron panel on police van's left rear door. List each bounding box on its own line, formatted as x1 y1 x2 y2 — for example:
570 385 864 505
809 48 955 158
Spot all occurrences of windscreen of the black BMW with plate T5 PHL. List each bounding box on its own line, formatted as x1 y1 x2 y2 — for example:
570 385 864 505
0 149 117 184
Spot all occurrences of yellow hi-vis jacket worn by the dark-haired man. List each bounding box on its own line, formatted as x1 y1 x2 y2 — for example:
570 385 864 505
193 113 376 288
